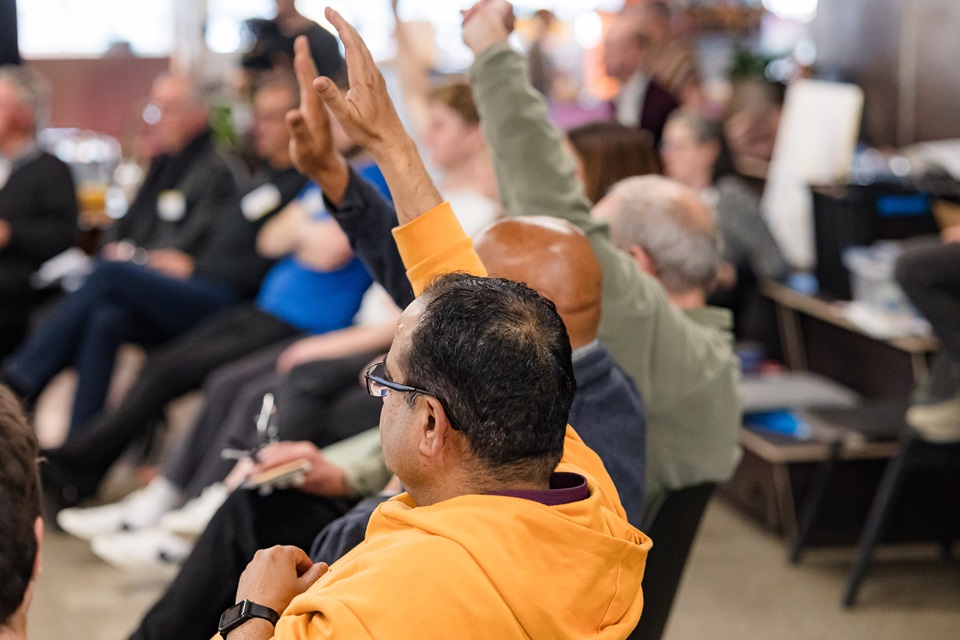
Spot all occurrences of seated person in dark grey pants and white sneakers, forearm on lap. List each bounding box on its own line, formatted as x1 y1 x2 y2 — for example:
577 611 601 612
57 289 400 552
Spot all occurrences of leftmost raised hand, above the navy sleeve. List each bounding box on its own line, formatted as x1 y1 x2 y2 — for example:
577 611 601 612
287 36 347 191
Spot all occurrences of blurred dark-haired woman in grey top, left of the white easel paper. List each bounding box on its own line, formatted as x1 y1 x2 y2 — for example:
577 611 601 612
661 110 790 297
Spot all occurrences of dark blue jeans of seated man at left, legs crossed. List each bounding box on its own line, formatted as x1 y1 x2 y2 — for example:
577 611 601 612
4 262 240 433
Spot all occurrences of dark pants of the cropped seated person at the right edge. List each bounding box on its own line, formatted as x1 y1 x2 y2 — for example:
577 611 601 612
896 239 960 401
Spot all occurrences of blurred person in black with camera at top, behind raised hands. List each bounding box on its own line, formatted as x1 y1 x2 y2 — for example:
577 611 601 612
241 0 345 86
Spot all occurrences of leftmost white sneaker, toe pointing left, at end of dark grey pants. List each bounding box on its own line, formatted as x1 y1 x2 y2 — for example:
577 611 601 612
57 477 182 540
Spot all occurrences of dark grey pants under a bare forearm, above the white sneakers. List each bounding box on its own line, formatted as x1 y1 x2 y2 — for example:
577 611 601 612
163 350 383 497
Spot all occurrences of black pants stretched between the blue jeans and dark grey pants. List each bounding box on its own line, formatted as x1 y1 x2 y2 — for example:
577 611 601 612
44 306 300 498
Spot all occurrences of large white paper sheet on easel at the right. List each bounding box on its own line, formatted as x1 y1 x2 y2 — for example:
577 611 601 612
761 80 863 269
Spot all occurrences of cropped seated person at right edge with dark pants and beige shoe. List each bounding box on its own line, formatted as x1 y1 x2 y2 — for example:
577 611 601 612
896 225 960 442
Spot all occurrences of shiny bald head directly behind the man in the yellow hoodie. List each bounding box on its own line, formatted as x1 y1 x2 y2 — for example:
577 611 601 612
474 217 602 349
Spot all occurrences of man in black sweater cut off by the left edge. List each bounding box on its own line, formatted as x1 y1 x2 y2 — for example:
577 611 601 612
0 67 77 357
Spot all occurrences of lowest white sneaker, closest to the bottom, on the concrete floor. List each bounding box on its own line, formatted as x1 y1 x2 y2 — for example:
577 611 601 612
90 528 193 570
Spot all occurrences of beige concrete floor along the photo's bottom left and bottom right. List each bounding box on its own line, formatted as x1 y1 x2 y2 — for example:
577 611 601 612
29 500 960 640
